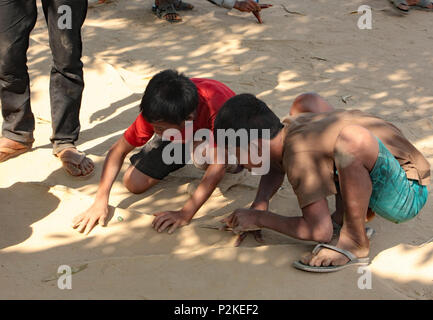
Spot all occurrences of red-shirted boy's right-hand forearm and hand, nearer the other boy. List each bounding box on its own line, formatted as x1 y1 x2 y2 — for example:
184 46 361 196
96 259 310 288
152 164 226 233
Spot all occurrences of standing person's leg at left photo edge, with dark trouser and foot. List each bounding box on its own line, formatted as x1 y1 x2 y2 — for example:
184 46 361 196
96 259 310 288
0 0 37 162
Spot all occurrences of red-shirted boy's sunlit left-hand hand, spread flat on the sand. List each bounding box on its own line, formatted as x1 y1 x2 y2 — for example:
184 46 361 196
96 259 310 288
72 203 108 235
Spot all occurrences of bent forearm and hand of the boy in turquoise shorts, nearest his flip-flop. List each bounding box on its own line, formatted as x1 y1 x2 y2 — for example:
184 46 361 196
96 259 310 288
224 199 332 242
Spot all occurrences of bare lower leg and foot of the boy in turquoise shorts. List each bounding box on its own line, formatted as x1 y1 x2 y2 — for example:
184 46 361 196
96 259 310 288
304 126 379 266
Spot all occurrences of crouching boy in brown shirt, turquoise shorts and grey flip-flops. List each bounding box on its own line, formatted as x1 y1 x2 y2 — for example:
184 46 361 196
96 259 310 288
214 94 430 272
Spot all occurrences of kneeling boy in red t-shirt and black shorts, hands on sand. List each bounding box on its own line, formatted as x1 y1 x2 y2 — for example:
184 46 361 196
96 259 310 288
73 70 253 240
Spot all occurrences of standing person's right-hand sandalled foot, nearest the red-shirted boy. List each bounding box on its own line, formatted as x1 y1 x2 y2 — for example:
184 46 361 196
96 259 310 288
56 147 95 177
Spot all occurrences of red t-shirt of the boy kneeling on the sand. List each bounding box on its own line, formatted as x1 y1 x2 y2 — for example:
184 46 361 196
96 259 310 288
123 78 235 147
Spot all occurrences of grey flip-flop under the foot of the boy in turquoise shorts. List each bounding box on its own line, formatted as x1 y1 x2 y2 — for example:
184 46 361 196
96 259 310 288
293 243 370 273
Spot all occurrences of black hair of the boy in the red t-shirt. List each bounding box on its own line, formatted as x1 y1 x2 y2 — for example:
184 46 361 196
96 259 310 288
140 70 198 124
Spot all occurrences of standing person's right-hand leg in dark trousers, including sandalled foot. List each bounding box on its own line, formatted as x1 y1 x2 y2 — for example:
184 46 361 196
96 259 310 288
42 0 94 176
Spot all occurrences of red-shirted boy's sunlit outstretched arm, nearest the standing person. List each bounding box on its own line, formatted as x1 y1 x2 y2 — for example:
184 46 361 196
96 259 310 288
72 136 135 234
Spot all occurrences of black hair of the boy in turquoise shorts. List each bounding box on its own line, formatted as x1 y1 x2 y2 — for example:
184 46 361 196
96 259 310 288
214 93 283 144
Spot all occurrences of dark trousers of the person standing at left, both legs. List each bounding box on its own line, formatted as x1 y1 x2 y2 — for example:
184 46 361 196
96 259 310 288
0 0 87 153
